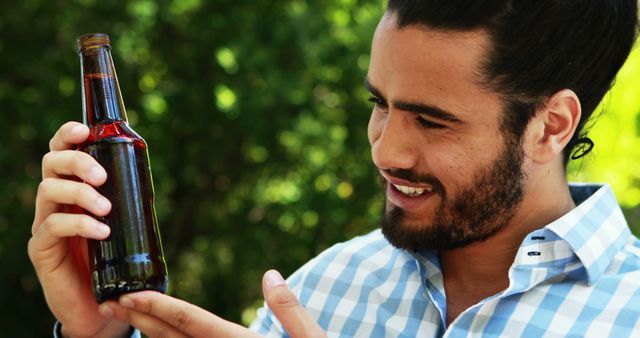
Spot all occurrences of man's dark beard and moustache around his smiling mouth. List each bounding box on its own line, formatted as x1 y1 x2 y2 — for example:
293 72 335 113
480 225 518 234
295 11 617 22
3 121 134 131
381 139 524 251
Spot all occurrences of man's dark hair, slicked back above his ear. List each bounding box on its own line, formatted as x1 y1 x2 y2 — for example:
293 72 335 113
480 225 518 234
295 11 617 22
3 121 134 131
387 0 638 165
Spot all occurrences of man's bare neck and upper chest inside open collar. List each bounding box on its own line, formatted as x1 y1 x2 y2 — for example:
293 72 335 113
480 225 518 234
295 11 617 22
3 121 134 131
440 159 575 321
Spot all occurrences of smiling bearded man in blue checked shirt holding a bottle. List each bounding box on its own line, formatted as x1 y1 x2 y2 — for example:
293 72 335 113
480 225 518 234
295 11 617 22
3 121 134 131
29 0 640 337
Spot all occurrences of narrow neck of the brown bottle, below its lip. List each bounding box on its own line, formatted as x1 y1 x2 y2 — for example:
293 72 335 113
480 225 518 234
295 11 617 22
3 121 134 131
80 45 127 127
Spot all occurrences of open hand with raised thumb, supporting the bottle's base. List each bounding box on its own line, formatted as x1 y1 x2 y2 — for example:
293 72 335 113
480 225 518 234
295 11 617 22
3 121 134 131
100 270 326 338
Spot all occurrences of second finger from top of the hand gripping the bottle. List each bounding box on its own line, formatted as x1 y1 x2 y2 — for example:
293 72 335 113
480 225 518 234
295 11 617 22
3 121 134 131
42 150 107 186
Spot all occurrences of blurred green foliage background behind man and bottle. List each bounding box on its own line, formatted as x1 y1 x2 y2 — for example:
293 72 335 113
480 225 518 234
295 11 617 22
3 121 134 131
0 0 640 337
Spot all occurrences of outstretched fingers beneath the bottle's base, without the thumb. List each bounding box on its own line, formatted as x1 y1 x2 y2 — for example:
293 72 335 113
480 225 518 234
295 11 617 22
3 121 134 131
101 291 258 337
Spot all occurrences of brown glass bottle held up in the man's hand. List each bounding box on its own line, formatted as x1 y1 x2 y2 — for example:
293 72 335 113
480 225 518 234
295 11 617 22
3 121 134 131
78 34 169 303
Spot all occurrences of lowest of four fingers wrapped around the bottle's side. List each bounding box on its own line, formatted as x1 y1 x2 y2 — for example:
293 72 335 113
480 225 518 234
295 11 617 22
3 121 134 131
30 213 111 255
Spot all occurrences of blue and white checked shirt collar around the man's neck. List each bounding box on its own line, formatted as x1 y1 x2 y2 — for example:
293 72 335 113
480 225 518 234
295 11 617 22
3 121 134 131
412 183 631 291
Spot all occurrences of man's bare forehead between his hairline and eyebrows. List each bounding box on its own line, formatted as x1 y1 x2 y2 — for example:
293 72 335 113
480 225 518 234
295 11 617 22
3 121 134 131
367 14 501 123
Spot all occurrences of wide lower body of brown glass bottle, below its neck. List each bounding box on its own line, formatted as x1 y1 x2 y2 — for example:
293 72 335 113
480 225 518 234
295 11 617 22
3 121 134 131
79 122 169 302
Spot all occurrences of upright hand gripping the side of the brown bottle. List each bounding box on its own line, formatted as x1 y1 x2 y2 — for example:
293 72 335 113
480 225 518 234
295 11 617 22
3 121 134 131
28 122 128 337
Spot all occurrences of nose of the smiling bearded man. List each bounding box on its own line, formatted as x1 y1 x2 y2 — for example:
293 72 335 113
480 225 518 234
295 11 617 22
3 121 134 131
369 111 419 169
